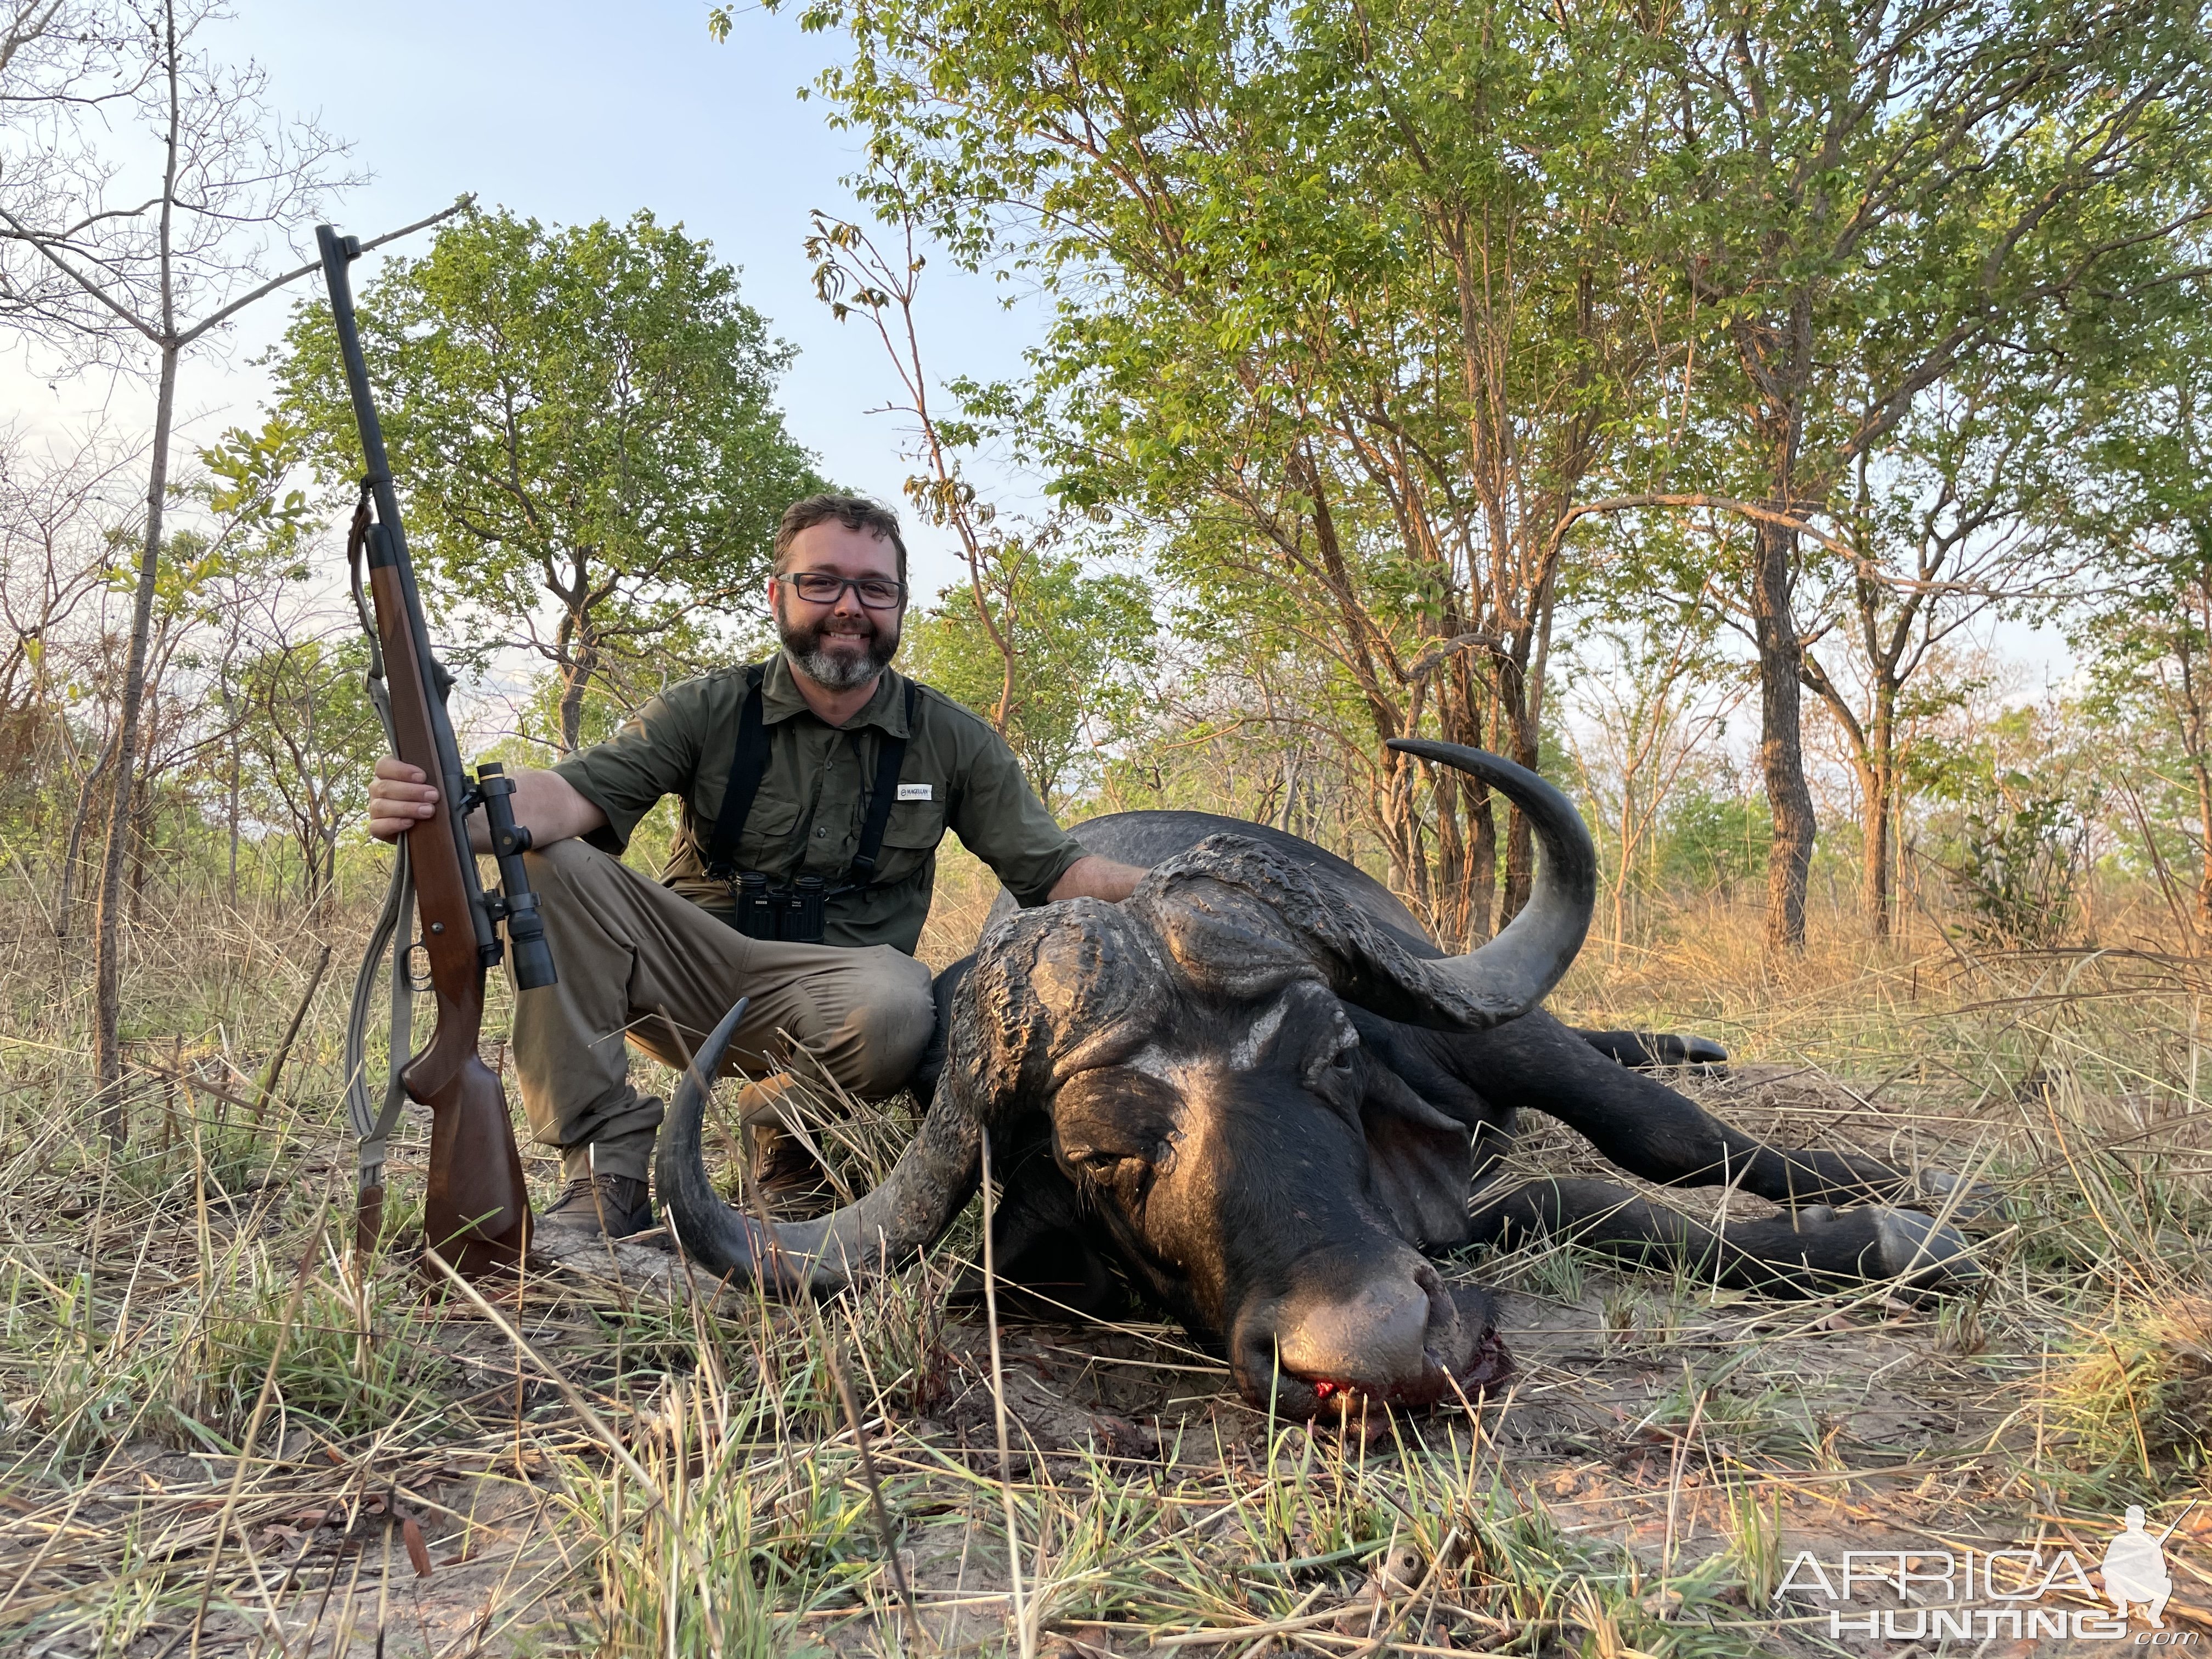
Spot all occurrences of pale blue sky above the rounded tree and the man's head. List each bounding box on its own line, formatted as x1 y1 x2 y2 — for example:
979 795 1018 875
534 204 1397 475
0 0 1033 606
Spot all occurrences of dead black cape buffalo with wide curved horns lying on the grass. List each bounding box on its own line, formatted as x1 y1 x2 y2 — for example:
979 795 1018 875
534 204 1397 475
659 743 1973 1413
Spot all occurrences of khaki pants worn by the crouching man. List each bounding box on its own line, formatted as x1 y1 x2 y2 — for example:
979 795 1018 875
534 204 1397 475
513 840 936 1181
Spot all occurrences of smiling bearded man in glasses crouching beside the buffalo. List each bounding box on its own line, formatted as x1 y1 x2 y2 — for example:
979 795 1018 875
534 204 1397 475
369 495 1144 1239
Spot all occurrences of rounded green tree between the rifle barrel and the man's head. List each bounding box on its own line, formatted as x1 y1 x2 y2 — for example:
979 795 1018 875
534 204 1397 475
274 212 823 752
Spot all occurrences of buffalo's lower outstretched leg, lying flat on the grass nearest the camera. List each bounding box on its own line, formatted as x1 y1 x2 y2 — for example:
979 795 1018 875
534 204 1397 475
1473 1179 1980 1296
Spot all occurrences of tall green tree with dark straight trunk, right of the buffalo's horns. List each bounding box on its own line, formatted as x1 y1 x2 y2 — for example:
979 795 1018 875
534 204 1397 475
1659 0 2212 949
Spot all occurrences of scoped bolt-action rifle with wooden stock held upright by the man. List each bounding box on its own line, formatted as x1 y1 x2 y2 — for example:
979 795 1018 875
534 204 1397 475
314 225 553 1278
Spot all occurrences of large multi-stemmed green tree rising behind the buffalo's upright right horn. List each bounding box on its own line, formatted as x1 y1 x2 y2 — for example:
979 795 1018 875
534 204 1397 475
756 0 1668 938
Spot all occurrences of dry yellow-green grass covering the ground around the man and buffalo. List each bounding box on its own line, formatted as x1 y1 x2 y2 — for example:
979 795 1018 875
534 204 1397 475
0 872 2212 1659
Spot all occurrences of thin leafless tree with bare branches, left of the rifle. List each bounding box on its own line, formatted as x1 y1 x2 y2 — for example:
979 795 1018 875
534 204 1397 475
0 0 420 1119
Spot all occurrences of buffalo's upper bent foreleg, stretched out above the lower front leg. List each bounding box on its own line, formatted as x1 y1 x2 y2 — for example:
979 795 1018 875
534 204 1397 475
1442 1013 1929 1205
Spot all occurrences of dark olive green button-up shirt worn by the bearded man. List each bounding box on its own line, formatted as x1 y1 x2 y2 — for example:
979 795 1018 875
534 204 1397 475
553 652 1082 953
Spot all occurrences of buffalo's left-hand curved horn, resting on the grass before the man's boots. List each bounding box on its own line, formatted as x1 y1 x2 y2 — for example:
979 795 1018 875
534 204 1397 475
657 1000 978 1294
